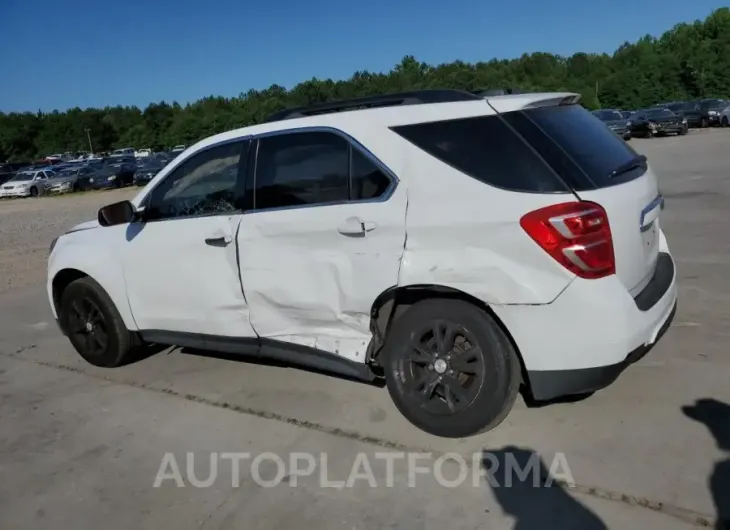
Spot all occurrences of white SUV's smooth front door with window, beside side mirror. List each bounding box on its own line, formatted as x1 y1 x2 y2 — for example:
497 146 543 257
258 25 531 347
122 140 256 337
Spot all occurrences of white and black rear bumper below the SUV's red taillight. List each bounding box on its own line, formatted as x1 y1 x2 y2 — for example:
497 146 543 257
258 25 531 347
493 235 677 400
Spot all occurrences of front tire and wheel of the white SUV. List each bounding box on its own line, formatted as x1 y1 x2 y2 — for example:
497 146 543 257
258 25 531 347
59 277 137 368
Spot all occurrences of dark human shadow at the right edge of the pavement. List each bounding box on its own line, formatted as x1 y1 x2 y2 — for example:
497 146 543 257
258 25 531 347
682 398 730 530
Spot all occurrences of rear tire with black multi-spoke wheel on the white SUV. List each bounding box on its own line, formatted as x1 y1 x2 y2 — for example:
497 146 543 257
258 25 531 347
381 299 521 438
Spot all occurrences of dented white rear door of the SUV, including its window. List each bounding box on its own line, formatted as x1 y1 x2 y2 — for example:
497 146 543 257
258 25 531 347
238 129 406 361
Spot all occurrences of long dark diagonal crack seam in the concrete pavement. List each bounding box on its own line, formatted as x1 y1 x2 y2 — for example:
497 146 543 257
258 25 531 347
5 345 719 528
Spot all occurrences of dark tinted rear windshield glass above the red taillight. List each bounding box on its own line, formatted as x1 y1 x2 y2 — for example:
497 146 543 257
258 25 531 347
502 105 646 191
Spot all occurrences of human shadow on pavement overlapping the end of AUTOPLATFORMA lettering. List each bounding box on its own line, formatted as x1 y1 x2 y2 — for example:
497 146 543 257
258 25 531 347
483 446 608 530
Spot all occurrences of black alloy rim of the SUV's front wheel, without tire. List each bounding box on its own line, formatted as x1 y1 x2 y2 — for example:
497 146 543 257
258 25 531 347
67 294 109 358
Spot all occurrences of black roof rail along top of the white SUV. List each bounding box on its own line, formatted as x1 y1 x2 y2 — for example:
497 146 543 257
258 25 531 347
266 89 482 122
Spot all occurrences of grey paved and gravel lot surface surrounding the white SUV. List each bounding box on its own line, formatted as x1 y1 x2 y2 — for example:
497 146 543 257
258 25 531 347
0 130 730 530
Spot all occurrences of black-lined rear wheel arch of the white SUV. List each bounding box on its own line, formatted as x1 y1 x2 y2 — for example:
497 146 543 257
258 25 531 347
365 284 529 384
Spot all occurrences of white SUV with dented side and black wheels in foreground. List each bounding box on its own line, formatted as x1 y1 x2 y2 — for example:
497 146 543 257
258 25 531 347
48 90 677 437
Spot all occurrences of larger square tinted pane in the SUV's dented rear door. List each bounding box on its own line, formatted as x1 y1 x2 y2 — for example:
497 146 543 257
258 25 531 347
255 132 350 209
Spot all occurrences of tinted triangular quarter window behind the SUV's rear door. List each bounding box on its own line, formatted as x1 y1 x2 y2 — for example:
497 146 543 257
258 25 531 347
393 111 564 193
